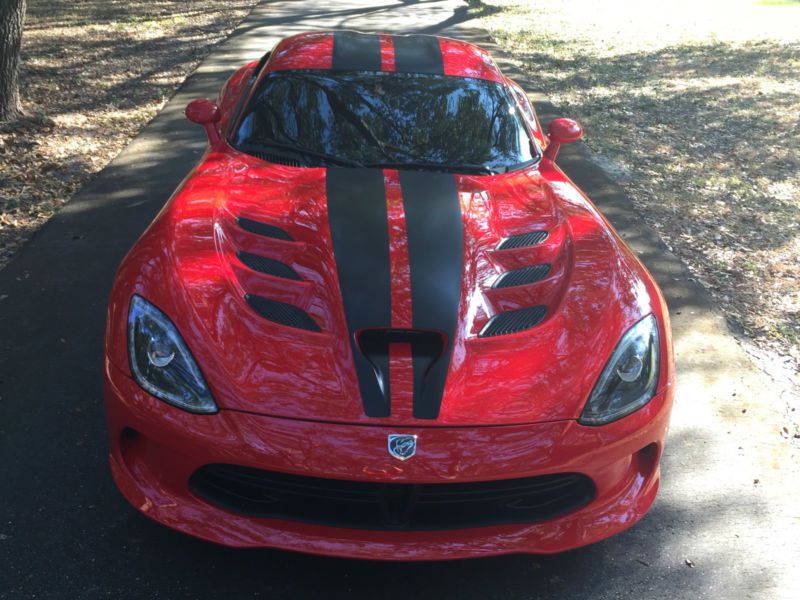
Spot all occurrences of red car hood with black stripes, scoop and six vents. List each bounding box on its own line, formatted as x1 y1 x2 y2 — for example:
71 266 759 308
112 151 658 426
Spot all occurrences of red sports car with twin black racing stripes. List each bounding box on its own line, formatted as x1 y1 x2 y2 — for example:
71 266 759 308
105 31 674 560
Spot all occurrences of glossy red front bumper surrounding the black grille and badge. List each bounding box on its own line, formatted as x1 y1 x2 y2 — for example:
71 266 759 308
105 360 672 560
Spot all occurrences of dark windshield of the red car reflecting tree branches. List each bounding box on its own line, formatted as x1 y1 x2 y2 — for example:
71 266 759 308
232 70 538 173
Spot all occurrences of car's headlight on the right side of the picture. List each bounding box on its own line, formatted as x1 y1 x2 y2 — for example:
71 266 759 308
578 315 659 425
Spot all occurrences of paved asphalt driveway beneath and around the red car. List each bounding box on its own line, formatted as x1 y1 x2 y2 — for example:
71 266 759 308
0 0 800 599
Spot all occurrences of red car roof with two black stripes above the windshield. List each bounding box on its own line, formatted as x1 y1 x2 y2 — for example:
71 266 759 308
262 30 505 82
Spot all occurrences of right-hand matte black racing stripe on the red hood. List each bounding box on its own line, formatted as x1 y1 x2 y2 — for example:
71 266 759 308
400 171 464 419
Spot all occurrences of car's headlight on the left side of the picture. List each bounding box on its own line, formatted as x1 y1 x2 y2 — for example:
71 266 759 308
128 296 217 414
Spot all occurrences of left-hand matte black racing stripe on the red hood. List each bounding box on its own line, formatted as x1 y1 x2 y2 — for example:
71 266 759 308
326 167 392 417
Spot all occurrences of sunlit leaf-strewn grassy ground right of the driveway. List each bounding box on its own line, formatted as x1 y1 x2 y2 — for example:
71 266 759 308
473 0 800 378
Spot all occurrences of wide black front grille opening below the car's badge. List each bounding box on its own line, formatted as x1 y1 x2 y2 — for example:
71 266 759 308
190 465 595 531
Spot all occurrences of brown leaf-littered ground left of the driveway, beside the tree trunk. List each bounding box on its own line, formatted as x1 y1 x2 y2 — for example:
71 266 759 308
0 0 258 268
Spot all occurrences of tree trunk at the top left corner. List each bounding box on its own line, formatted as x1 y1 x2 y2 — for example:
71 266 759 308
0 0 25 123
